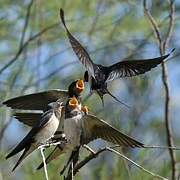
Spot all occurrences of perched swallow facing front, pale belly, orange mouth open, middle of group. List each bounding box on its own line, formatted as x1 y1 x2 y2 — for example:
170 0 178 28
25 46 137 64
37 97 83 174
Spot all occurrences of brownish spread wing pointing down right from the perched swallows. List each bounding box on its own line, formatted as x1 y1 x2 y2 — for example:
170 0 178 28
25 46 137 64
83 115 143 147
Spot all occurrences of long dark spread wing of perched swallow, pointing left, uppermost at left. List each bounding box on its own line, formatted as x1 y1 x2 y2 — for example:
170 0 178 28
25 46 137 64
3 89 68 110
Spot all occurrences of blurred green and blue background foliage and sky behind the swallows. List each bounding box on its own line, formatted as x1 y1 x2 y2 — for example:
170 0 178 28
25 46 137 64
0 0 180 180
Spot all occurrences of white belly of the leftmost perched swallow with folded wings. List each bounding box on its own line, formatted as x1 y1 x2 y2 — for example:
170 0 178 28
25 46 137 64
35 114 59 143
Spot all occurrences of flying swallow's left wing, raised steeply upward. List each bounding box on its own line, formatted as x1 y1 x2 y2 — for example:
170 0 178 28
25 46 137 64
60 9 96 78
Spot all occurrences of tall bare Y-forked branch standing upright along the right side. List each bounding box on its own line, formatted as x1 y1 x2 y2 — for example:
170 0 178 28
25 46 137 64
143 0 176 180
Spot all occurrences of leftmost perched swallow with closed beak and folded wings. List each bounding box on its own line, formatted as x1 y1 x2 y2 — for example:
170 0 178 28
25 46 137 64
6 102 63 171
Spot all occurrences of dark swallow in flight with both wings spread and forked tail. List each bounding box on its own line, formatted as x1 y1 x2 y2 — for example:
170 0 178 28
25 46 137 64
60 9 174 106
